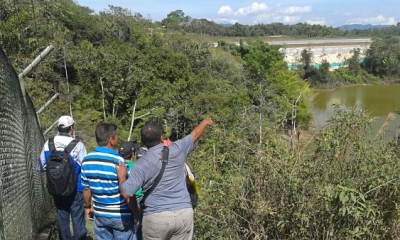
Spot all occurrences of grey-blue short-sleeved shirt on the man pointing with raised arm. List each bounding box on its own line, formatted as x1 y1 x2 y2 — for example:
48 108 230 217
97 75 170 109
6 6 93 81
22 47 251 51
122 135 194 215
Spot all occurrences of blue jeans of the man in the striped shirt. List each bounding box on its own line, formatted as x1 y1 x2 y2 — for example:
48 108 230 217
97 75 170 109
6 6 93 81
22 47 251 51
93 216 136 240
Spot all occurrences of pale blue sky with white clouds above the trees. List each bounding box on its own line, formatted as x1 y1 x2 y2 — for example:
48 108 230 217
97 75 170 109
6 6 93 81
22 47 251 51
76 0 400 27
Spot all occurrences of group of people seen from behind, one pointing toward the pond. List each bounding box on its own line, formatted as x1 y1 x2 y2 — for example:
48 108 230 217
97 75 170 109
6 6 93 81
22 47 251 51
37 116 213 240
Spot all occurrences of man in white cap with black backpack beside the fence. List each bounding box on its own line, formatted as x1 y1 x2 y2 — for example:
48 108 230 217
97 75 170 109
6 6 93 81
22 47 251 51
36 115 87 240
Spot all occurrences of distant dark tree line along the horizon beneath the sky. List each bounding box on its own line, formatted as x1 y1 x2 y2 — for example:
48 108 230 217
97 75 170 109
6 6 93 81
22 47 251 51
161 10 400 38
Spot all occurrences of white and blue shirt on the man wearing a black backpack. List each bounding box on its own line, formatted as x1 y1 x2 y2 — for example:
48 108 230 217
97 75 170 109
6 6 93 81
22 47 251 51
36 135 86 192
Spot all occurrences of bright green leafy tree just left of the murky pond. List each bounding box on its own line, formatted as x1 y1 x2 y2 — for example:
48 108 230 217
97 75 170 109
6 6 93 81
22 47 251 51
239 40 311 128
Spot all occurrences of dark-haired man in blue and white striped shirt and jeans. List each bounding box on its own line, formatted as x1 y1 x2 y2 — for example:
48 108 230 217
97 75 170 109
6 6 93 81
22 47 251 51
81 123 140 240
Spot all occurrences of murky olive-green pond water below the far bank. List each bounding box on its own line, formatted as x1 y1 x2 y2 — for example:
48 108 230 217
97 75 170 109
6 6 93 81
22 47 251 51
313 85 400 136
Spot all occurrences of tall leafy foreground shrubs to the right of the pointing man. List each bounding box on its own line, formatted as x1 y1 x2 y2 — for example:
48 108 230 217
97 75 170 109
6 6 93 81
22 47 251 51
190 108 400 239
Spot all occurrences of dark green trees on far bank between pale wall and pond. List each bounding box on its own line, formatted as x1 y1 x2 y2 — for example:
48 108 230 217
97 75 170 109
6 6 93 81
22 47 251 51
297 36 400 88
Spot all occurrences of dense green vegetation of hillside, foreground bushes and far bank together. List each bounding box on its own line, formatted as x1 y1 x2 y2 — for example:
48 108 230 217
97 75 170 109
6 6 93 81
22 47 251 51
0 0 400 239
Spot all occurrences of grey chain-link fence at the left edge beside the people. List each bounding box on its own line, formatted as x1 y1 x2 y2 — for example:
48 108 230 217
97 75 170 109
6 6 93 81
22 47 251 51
0 49 53 240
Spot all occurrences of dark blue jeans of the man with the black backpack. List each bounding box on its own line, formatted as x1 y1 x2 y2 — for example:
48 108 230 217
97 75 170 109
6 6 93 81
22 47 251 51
53 192 87 240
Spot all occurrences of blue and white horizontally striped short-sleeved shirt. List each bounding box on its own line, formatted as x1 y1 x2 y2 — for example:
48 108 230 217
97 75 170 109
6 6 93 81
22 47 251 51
81 146 132 218
